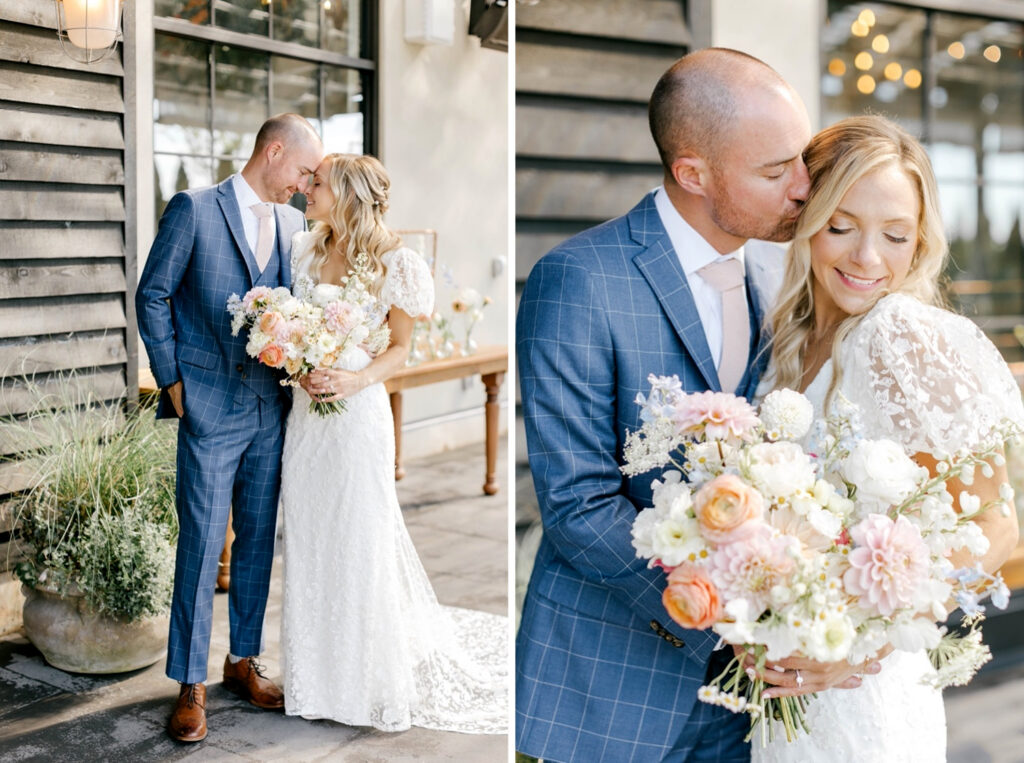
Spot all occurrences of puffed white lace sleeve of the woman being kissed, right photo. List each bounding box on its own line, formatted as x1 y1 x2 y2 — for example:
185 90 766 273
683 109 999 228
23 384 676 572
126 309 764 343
842 294 1024 454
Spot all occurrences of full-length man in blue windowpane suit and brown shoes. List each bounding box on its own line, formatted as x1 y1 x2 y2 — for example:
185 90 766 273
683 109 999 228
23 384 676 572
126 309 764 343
135 114 324 741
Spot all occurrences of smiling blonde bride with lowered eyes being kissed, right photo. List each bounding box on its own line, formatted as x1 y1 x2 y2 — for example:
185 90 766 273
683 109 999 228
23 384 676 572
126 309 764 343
753 117 1024 763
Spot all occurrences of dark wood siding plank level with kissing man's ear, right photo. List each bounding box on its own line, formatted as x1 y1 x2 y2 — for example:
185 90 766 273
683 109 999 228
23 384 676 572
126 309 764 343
515 169 662 221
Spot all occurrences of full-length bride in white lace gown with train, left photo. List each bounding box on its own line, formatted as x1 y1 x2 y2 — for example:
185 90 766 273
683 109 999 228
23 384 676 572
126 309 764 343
281 154 508 733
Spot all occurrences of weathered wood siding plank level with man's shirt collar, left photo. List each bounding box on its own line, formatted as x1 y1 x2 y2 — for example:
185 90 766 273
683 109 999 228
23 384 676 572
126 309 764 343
0 182 125 221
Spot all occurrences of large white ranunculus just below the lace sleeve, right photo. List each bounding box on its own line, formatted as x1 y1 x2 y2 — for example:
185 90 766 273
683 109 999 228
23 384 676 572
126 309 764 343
842 439 928 509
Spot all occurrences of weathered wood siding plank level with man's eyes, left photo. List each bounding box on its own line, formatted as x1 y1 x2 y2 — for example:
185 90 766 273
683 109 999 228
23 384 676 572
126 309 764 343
0 141 125 185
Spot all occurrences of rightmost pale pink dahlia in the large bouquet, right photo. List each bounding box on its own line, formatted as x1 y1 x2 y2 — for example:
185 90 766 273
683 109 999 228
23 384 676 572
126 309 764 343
843 507 930 617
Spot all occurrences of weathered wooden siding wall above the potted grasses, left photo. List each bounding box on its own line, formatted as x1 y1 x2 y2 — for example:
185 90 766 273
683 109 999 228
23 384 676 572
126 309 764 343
0 0 137 570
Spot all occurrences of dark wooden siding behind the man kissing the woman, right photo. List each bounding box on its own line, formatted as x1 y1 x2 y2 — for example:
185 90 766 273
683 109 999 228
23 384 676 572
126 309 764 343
515 0 691 487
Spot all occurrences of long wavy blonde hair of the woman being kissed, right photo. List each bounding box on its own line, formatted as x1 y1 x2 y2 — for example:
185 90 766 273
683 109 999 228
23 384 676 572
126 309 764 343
769 116 948 410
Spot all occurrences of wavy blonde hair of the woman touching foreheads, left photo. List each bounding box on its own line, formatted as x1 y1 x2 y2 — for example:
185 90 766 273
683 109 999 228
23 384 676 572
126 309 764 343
309 154 401 294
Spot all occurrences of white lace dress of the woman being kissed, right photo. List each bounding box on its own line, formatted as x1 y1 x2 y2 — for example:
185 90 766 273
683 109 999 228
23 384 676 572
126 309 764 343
752 294 1024 763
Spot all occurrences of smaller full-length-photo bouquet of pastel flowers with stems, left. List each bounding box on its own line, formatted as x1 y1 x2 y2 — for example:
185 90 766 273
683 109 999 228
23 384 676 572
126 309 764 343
227 255 390 416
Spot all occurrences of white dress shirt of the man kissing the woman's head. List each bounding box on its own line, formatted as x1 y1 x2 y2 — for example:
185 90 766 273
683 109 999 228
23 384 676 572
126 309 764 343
654 185 745 368
